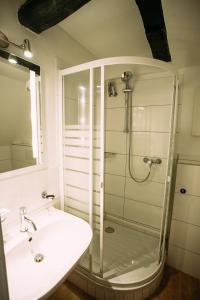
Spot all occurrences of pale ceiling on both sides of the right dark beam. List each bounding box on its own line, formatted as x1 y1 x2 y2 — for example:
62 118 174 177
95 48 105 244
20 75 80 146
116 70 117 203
59 0 200 67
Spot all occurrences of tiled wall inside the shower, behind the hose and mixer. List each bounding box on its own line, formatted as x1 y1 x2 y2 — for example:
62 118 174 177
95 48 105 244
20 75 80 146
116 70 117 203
105 76 173 230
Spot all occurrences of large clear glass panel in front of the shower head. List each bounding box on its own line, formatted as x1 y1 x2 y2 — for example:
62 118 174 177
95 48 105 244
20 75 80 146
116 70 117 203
103 65 173 282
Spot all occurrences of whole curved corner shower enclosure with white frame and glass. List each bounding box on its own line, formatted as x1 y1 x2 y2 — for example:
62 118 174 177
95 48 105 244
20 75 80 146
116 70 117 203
59 57 178 296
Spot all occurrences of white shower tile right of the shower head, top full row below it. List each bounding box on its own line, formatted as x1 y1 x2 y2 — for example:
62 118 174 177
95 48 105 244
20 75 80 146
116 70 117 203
132 77 173 106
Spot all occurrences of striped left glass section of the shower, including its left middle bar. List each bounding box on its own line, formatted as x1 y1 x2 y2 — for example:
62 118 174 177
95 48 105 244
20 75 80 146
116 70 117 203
62 68 101 274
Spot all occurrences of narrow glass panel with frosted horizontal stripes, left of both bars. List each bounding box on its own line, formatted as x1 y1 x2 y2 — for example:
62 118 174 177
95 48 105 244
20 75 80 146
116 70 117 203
63 70 90 269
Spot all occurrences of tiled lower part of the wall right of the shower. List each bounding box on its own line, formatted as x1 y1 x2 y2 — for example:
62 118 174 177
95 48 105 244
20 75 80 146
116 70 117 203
168 161 200 279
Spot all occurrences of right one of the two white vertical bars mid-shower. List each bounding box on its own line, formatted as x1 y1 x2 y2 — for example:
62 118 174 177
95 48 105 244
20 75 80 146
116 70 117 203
100 66 105 277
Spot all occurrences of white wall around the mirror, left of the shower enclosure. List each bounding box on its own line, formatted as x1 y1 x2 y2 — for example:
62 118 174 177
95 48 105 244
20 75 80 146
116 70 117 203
0 0 92 225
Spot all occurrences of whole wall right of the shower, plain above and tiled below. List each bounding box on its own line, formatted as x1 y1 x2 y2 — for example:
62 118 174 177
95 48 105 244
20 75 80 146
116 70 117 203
168 66 200 278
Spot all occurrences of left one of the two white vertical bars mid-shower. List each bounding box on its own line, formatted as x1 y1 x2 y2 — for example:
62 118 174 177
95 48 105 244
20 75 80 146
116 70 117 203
89 68 94 272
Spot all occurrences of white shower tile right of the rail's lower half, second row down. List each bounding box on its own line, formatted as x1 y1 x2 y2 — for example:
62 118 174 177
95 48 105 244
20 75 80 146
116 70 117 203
132 105 171 132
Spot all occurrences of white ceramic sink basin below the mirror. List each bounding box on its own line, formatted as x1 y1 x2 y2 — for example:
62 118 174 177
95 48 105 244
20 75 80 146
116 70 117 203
5 208 92 300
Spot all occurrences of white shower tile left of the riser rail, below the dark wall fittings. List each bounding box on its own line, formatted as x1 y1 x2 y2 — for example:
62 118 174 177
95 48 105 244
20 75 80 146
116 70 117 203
105 108 125 131
